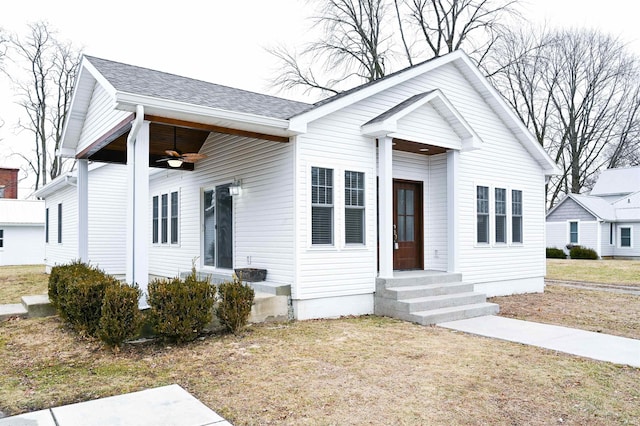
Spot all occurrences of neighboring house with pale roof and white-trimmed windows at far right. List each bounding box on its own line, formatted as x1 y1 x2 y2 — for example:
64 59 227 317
547 167 640 258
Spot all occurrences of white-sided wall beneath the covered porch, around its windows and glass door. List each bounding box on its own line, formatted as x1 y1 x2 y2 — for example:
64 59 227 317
149 133 294 284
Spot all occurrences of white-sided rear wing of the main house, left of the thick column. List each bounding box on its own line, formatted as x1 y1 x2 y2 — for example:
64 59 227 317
34 163 127 276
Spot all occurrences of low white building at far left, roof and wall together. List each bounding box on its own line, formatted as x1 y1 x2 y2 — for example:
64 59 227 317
0 198 45 266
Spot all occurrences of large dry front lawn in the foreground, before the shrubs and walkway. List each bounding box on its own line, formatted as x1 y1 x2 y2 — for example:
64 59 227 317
0 317 640 425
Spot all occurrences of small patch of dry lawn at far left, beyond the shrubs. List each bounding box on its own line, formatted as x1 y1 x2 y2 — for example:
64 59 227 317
0 265 49 303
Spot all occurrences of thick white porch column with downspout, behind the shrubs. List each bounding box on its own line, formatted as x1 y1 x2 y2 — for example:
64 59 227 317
126 121 149 307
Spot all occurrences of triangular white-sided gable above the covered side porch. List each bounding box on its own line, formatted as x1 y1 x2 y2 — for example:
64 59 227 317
76 84 131 152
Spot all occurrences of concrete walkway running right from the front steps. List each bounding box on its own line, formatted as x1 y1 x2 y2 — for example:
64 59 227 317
438 315 640 367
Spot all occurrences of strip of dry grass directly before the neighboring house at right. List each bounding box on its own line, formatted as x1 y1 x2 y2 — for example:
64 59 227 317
546 259 640 287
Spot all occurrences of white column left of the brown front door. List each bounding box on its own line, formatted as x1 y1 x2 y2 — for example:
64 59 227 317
378 136 393 278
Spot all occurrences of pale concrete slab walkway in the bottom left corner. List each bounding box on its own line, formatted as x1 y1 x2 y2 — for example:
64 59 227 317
0 385 231 426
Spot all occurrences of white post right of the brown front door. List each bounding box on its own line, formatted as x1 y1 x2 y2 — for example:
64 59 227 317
447 149 460 272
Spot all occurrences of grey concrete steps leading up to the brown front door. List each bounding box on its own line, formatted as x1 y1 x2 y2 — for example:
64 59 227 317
374 271 500 325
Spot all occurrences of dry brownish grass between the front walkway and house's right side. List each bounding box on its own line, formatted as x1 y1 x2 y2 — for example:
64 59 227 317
490 285 640 339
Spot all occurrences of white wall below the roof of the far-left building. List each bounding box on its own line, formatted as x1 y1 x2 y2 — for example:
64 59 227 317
0 224 44 266
